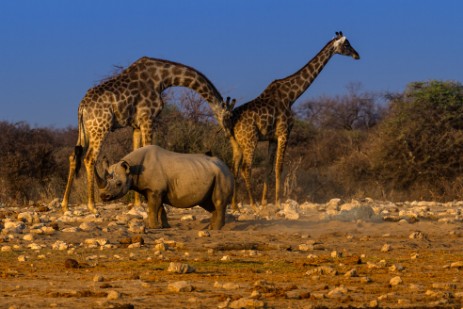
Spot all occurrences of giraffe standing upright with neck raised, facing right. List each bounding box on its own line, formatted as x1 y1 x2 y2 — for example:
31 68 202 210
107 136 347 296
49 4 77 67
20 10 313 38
229 32 360 210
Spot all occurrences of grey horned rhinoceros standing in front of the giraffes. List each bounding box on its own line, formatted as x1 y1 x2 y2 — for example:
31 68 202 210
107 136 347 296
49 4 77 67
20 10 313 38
95 145 234 229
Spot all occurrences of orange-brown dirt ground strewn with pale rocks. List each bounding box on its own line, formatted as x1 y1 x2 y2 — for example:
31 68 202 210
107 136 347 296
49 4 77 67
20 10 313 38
0 199 463 308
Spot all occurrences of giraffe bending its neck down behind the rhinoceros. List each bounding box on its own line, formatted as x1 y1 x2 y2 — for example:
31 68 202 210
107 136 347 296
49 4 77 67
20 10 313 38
61 57 233 213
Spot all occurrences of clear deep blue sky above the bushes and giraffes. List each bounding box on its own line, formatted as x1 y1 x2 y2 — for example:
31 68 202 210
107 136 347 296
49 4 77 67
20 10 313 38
0 0 463 128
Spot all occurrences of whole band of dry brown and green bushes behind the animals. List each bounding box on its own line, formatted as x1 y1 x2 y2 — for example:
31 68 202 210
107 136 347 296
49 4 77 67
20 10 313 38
0 81 463 204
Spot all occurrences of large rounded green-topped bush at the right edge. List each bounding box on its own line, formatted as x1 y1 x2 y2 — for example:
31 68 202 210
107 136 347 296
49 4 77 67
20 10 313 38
369 81 463 197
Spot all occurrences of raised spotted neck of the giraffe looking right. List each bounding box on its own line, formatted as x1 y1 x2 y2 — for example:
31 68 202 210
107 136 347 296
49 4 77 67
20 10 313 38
262 40 334 106
